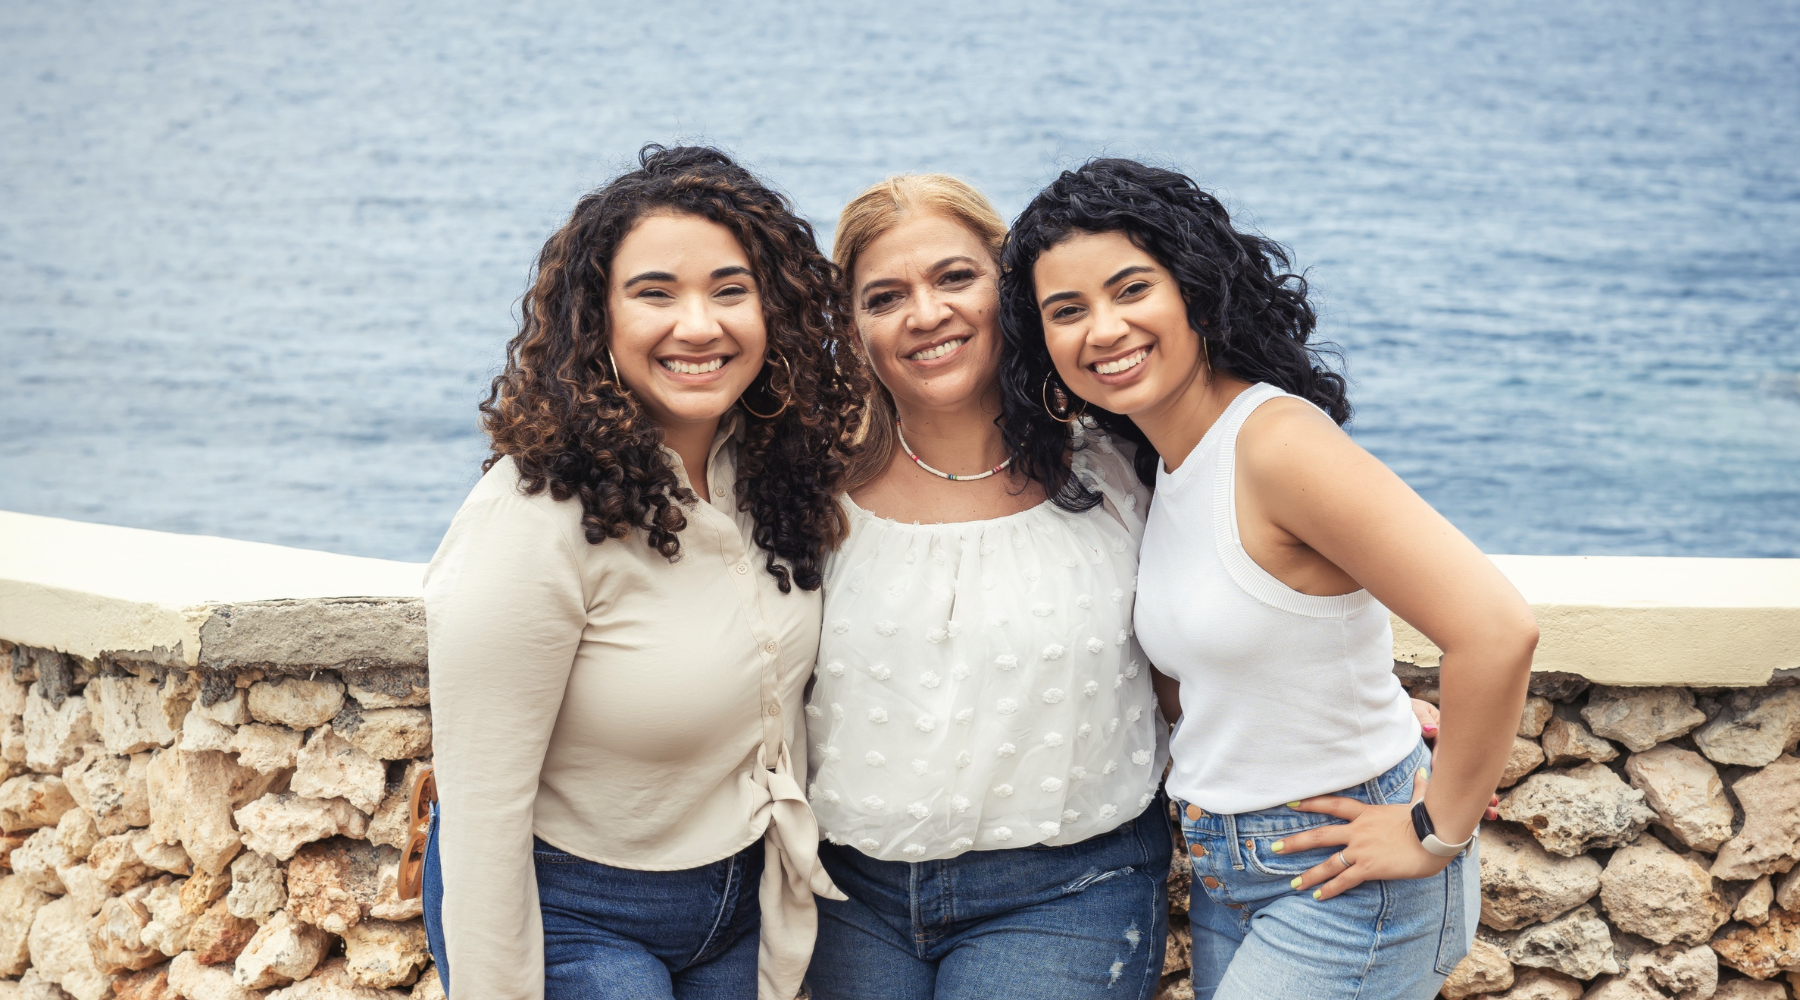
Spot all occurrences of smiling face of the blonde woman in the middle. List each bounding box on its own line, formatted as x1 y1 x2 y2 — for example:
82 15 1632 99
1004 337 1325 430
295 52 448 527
851 212 1001 410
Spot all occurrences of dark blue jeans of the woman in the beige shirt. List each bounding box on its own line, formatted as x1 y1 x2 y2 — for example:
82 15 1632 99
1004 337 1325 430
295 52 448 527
423 804 763 1000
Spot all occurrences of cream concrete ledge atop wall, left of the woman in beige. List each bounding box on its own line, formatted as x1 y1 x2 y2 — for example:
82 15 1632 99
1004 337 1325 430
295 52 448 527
0 511 425 669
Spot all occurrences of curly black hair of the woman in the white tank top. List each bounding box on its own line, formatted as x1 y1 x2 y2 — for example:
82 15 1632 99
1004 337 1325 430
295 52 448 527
1001 158 1350 511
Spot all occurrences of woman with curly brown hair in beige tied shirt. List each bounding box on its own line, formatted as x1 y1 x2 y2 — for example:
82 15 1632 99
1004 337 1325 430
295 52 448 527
425 146 868 1000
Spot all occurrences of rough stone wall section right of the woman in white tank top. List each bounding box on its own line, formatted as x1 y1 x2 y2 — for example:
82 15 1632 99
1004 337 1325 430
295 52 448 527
1159 667 1800 1000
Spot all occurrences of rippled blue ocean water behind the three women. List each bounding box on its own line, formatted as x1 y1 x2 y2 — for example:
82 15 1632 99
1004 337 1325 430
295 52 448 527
0 0 1800 559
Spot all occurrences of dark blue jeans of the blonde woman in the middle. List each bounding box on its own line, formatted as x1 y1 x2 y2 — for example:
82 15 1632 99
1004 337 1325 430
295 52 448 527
806 795 1174 1000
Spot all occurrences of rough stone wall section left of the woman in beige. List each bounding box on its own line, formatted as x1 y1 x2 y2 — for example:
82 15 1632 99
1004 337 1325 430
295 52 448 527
0 642 443 1000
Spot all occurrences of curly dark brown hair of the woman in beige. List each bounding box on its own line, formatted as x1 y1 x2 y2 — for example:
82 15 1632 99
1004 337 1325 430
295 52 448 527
481 144 869 594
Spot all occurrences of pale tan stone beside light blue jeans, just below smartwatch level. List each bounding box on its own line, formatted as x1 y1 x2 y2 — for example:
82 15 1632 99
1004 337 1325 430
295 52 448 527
1481 824 1600 930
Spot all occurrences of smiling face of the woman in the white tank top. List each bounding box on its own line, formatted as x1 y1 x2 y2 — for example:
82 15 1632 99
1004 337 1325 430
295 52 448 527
1031 232 1204 415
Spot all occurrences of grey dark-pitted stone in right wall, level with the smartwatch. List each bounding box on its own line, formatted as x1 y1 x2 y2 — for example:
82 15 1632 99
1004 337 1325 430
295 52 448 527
1499 764 1656 856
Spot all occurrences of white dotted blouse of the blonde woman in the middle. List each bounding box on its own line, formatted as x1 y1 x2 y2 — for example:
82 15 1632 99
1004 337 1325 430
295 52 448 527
806 430 1168 862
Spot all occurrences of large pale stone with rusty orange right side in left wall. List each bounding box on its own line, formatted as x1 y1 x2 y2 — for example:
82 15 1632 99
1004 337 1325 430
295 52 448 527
148 750 272 872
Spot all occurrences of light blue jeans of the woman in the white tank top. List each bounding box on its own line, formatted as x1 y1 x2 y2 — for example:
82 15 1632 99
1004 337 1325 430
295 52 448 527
1177 743 1481 1000
